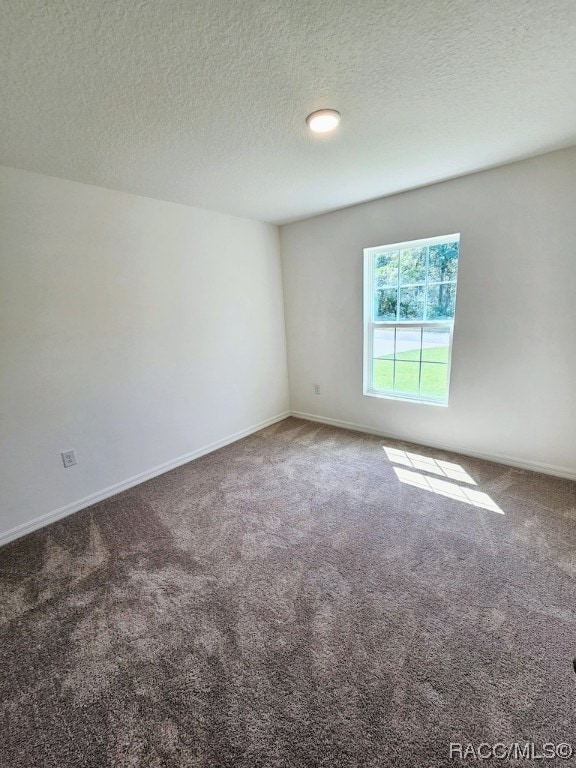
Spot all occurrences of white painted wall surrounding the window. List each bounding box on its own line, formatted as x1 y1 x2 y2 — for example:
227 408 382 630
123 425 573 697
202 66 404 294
281 149 576 476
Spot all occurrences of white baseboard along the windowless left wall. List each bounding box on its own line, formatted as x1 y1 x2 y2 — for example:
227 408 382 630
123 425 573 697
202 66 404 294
0 411 290 547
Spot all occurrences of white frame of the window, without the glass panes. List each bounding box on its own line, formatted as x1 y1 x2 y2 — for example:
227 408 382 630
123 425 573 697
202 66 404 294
363 232 460 407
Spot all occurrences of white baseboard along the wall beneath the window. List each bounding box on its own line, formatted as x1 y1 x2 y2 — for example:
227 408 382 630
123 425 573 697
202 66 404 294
290 411 576 480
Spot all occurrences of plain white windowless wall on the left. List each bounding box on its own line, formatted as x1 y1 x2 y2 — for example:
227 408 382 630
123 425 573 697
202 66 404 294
0 168 288 536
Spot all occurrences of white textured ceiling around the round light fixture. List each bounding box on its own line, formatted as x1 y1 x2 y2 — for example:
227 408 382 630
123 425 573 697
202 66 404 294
0 0 576 222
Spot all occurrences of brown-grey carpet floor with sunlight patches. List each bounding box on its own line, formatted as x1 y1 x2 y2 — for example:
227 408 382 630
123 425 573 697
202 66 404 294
0 418 576 768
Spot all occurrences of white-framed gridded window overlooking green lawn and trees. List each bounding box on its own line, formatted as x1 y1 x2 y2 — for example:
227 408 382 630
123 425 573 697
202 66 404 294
364 235 460 404
